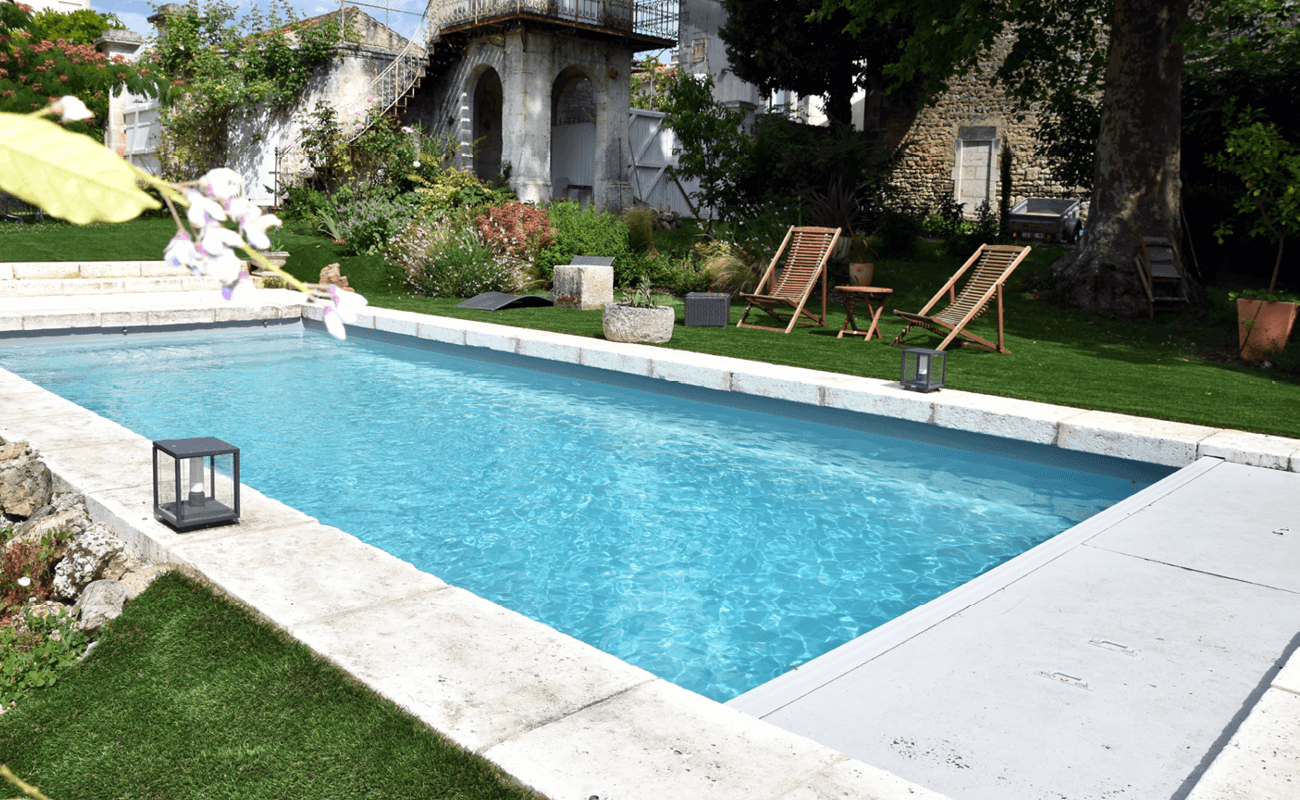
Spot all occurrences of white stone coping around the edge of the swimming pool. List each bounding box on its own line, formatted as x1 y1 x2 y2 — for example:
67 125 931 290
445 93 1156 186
0 293 1300 799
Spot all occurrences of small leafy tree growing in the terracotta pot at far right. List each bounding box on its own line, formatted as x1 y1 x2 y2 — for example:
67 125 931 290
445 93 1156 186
1208 107 1300 294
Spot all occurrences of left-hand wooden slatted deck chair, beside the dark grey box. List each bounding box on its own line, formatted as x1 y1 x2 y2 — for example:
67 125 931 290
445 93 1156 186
736 228 842 333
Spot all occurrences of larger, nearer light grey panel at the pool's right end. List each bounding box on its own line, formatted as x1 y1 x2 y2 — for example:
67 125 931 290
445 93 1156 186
764 538 1300 800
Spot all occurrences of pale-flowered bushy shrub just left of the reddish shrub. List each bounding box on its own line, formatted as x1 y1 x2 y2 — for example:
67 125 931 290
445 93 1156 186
385 217 521 297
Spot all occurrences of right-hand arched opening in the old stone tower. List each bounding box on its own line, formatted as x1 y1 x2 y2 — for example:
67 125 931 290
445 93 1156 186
551 66 597 206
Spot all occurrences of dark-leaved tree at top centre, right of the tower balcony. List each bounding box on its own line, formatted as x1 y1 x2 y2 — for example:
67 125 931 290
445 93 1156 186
718 0 905 125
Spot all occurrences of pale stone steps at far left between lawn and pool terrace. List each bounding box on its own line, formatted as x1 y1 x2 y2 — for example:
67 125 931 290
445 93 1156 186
0 261 221 298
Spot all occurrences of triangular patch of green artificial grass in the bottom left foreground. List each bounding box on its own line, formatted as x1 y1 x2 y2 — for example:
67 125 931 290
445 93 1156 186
0 572 537 800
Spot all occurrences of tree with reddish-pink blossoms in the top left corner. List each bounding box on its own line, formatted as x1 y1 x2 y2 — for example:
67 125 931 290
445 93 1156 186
0 3 159 138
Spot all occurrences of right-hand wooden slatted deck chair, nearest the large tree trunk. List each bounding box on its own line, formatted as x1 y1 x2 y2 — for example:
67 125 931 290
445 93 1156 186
889 245 1030 353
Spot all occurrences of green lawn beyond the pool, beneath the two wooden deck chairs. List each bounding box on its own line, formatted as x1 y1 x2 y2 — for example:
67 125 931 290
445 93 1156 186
0 219 1300 438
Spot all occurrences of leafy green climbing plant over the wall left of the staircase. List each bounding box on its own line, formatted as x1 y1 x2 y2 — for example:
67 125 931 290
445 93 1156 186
150 0 339 181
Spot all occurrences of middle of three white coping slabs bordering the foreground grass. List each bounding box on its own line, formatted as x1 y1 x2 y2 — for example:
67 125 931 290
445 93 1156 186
295 588 654 754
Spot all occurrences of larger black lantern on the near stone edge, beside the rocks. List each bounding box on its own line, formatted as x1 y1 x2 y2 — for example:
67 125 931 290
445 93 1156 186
153 436 239 531
